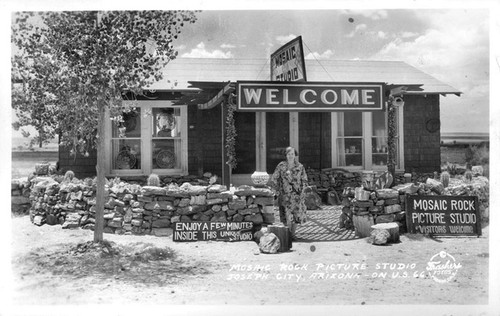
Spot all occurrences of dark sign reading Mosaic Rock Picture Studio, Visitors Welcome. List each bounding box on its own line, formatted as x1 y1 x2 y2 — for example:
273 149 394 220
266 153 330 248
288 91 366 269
406 195 481 236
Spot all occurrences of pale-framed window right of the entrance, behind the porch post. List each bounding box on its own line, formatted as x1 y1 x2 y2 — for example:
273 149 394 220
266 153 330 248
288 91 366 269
332 109 403 170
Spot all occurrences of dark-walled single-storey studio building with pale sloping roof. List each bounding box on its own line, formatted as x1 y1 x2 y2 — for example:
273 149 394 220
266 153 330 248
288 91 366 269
59 58 461 184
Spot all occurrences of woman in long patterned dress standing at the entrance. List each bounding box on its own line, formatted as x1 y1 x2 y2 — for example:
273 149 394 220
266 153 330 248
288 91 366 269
270 147 307 238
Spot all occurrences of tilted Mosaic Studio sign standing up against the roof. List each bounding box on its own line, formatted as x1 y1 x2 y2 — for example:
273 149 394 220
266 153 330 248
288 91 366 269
271 36 307 81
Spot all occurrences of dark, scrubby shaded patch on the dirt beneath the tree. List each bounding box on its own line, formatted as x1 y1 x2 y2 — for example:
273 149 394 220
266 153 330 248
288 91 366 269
13 240 211 286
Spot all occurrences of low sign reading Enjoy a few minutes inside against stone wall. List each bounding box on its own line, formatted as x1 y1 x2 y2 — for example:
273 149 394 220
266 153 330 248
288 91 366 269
173 222 253 241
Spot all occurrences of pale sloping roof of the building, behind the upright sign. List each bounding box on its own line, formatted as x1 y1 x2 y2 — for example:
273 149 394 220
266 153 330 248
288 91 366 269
150 58 462 95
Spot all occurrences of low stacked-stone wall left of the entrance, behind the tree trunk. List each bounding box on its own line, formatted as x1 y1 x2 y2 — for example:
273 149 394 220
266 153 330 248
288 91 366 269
23 177 274 236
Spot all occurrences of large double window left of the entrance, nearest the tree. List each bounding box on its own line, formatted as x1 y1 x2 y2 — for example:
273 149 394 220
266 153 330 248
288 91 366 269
107 101 187 175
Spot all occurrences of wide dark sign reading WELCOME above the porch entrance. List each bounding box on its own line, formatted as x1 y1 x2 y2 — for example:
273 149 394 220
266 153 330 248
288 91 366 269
236 81 384 112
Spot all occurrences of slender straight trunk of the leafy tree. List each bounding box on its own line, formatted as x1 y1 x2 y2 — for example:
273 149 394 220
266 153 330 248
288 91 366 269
94 104 106 242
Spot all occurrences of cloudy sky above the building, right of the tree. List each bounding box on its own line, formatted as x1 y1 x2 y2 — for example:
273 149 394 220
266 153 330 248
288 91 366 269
170 8 490 132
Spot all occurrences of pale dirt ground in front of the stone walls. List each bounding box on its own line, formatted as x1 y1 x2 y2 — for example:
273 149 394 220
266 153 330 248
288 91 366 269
3 212 489 315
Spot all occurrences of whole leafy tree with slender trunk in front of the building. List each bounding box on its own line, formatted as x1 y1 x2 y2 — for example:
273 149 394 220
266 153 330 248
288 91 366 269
12 11 196 242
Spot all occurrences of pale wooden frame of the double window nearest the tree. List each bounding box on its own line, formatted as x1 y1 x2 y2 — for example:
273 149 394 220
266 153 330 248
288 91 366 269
104 100 188 176
